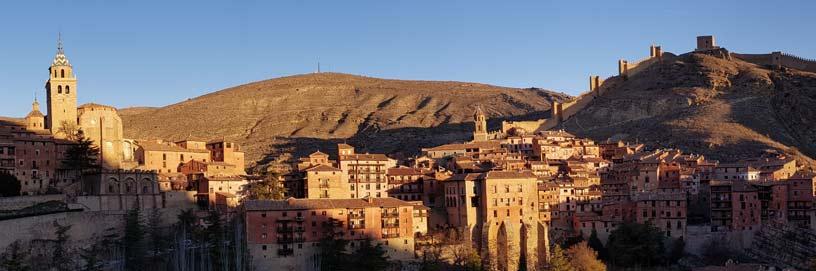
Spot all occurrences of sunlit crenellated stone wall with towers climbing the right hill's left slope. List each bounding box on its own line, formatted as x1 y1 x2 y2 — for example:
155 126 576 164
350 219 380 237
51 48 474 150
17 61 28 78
502 45 664 134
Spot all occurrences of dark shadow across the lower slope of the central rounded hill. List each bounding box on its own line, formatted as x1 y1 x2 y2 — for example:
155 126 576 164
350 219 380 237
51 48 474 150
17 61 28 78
258 110 550 165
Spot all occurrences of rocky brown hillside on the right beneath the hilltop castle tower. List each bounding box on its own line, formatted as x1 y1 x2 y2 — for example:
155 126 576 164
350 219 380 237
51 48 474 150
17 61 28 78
562 53 816 168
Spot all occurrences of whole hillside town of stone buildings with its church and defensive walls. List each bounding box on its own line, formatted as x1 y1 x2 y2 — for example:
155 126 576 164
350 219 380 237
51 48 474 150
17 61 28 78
0 36 816 270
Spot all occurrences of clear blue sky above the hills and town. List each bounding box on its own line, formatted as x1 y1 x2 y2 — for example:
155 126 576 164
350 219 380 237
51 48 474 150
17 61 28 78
0 0 816 117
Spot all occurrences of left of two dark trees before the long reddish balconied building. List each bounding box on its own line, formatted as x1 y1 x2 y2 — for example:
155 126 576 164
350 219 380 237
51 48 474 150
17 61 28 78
319 218 353 271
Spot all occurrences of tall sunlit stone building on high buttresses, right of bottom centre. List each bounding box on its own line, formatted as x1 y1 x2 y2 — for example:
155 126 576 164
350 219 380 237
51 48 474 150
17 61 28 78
443 171 548 270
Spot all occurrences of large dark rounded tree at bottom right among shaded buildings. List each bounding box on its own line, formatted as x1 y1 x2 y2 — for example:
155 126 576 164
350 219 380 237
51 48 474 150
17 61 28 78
606 223 665 267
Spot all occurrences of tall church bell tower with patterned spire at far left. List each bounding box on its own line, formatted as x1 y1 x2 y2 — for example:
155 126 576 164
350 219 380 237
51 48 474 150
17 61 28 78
45 37 77 138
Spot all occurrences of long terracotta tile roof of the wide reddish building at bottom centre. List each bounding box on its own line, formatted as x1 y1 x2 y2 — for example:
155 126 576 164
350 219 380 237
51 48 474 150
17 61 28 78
244 198 413 211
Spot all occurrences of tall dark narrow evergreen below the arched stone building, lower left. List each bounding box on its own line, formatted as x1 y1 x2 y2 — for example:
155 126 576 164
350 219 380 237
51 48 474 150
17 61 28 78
121 207 146 270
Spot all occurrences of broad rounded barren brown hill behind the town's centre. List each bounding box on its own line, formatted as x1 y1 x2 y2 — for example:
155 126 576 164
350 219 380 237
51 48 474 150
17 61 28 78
120 73 567 166
